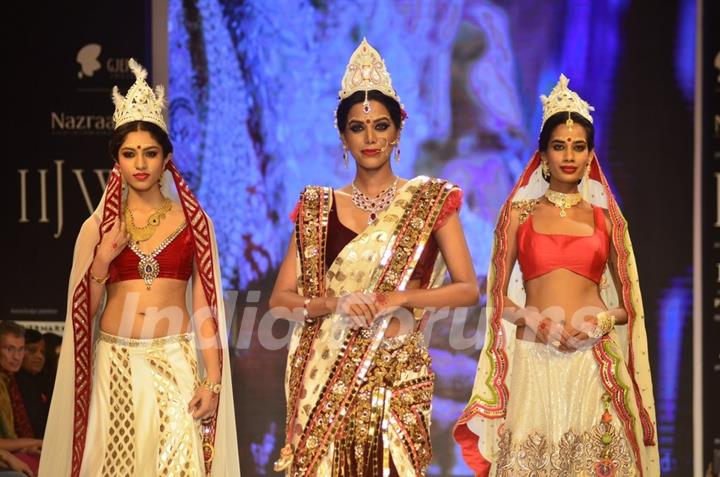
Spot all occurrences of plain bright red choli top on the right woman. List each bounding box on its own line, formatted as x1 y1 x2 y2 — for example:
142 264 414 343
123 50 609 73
517 206 610 285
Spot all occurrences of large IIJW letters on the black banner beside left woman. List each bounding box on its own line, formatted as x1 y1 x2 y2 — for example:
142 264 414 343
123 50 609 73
18 160 110 238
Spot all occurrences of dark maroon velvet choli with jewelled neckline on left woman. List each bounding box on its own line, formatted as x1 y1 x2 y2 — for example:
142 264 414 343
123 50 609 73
108 224 195 283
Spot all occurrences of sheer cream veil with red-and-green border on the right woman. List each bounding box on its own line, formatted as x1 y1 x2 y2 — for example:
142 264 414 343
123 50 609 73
453 153 660 477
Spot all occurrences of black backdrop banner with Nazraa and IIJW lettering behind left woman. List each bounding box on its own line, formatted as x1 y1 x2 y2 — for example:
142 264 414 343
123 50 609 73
1 0 152 321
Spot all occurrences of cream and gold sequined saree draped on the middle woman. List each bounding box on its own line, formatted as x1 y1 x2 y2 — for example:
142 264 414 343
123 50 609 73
278 177 458 477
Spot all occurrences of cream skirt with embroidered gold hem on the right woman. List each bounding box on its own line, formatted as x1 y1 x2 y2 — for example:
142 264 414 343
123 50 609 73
493 339 636 477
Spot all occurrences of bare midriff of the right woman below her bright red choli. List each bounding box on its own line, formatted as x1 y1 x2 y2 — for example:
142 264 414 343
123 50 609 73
516 268 607 341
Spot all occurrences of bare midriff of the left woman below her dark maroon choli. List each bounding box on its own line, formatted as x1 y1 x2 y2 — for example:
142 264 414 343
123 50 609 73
100 278 190 339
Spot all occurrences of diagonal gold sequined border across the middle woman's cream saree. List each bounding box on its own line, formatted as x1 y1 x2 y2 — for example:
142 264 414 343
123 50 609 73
291 178 452 477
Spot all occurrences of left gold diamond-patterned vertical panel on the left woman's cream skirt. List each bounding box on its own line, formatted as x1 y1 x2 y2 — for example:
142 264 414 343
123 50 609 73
101 345 135 476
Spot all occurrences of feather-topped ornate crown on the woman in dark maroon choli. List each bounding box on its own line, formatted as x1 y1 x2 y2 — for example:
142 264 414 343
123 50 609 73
113 58 167 132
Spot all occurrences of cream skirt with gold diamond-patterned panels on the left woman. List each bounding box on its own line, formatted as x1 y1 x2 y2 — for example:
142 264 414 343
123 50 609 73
81 332 204 477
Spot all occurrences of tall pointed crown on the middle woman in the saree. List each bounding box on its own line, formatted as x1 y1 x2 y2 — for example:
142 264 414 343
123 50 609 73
338 38 400 103
